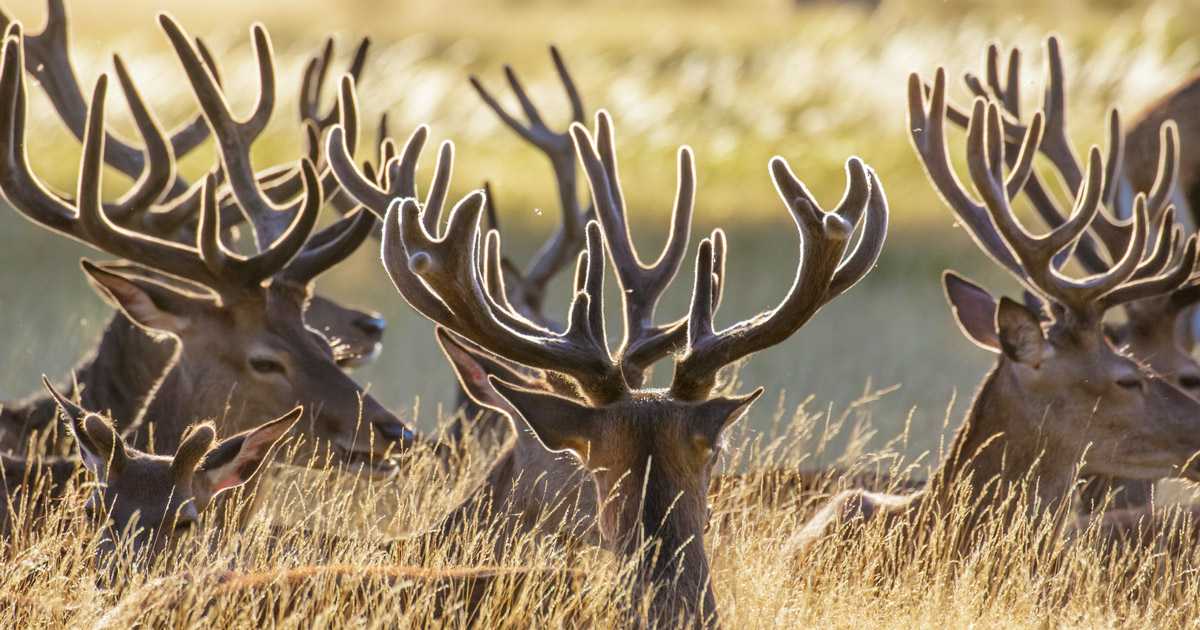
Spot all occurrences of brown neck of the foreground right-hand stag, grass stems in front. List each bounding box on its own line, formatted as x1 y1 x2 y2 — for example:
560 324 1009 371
924 359 1082 530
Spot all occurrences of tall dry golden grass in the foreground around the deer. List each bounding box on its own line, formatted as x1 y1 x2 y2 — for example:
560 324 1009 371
0 391 1200 629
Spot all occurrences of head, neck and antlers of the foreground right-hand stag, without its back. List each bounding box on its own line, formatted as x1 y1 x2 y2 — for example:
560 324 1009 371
908 68 1200 510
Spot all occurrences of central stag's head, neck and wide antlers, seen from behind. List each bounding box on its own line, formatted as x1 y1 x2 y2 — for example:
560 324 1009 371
326 106 887 624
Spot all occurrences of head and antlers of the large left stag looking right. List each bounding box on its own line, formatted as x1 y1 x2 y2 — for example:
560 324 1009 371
0 19 414 475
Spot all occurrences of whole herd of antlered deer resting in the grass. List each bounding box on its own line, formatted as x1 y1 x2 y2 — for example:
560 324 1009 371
0 0 1200 628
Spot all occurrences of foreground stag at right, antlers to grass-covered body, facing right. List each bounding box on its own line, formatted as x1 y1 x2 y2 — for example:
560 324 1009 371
787 68 1200 563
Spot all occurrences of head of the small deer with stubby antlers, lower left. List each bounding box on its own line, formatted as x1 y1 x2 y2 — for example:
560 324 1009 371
43 377 296 557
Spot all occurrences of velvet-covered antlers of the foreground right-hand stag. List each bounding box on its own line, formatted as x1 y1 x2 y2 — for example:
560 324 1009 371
908 68 1198 325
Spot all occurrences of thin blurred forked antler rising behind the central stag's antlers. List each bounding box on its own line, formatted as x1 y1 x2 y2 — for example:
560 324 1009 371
470 47 587 312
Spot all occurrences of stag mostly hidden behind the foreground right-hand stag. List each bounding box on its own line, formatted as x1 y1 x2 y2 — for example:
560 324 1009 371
931 36 1200 514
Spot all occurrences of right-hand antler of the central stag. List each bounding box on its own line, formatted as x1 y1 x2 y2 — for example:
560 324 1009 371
671 150 888 401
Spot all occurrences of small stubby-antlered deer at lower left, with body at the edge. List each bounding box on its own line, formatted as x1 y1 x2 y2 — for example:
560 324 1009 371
0 376 295 562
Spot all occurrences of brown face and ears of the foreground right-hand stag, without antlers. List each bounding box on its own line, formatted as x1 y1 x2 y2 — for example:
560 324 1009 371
944 274 1200 480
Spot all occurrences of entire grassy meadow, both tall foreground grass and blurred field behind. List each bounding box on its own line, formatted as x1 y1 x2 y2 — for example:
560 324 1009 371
0 0 1200 629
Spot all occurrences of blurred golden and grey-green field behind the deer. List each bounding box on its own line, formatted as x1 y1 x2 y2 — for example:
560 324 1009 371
0 0 1200 460
